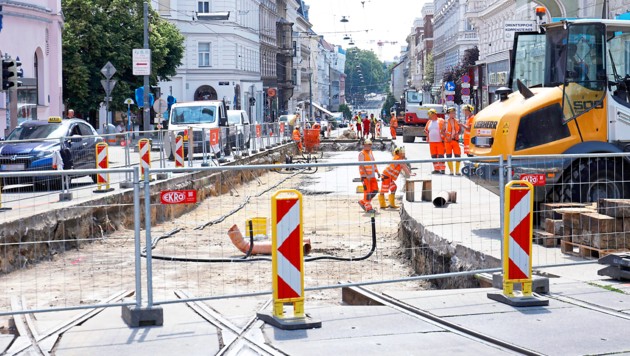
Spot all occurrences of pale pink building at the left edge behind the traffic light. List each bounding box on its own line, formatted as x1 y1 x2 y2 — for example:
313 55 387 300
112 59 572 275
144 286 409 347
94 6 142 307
0 0 63 137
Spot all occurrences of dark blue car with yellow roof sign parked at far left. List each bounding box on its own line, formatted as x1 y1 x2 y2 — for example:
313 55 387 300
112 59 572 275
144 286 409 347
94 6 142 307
0 117 103 186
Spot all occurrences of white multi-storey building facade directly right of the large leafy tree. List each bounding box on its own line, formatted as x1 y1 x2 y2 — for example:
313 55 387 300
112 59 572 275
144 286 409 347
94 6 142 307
158 0 266 122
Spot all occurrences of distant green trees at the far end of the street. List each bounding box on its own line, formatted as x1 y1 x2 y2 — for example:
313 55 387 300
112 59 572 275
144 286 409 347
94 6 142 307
345 47 389 105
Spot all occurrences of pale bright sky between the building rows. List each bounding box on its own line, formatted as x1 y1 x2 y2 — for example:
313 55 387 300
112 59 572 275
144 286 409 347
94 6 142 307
305 0 425 61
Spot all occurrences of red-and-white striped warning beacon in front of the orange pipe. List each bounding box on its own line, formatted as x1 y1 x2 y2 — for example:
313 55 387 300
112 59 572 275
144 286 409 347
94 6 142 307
257 189 322 330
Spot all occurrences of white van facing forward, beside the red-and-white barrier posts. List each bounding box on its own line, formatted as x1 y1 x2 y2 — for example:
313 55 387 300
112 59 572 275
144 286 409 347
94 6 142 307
164 100 231 160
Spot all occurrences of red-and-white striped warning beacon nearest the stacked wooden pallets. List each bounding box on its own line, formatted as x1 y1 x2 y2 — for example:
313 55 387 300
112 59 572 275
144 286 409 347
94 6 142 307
488 181 549 307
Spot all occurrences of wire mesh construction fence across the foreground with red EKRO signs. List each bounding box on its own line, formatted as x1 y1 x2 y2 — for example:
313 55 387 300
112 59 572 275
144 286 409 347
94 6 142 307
0 149 628 314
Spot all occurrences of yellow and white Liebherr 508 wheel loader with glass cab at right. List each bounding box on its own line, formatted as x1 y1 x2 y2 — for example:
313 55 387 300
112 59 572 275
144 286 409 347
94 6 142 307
463 15 630 202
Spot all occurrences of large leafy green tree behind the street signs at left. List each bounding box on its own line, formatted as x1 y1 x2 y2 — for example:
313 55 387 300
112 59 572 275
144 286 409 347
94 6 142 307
62 0 184 113
